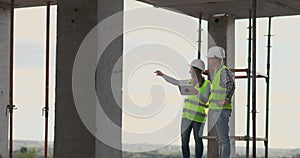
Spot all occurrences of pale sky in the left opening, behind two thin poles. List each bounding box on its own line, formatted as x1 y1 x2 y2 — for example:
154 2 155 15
14 6 56 140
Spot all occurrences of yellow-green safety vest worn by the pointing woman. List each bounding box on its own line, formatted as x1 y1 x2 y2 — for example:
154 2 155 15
182 80 210 123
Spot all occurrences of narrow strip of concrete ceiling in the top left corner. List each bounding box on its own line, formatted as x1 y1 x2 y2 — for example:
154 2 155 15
0 0 57 8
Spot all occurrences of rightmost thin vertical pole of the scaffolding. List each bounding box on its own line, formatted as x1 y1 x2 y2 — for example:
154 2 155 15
265 17 272 158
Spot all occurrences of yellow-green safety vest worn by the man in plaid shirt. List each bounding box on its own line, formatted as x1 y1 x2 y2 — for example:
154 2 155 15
209 66 232 110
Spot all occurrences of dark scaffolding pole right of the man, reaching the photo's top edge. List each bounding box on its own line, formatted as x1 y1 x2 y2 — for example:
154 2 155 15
252 0 257 158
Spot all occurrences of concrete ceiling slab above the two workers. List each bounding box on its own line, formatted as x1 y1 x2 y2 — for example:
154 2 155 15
137 0 300 19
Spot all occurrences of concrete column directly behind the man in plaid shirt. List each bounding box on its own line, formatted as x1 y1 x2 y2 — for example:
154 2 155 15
208 16 235 158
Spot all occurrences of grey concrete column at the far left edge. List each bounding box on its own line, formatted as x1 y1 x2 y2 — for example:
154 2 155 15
0 8 10 158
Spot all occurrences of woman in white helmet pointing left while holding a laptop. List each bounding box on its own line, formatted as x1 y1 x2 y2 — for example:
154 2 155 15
155 59 211 158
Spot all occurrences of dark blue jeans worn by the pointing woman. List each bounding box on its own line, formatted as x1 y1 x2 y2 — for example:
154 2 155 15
181 118 204 158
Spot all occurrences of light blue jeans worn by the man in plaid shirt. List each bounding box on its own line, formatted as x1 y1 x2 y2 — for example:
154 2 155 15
209 109 231 158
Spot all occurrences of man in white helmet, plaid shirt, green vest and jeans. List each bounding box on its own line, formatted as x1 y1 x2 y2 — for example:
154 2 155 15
207 46 235 158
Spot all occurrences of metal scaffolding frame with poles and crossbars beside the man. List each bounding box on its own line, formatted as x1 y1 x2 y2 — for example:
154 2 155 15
198 0 272 158
